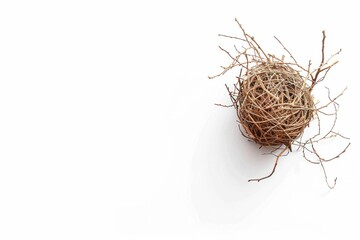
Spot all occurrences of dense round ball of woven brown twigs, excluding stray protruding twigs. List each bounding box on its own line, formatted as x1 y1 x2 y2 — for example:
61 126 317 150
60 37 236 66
237 62 314 148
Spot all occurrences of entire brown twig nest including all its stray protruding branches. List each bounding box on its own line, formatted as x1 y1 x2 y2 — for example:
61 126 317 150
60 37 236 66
209 19 350 188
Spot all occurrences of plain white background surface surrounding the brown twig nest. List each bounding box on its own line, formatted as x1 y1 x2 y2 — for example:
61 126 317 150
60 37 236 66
0 0 360 240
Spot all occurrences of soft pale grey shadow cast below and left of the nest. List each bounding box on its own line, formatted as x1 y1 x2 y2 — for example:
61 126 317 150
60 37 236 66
191 109 287 224
